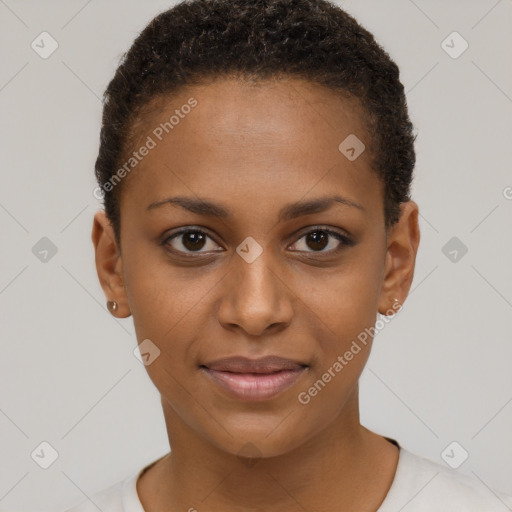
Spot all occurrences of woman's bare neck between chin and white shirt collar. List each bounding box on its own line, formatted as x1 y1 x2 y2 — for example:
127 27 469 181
138 390 398 512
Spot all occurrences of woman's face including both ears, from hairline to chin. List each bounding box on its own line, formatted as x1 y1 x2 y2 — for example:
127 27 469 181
93 79 419 456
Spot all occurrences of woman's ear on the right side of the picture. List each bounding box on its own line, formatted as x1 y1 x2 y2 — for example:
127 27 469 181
378 201 420 315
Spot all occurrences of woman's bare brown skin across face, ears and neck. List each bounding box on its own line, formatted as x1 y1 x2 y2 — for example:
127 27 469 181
92 79 420 512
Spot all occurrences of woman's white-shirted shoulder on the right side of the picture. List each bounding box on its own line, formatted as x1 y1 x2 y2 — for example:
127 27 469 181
378 448 512 512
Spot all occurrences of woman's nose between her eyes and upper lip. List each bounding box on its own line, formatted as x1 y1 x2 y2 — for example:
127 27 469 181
218 251 294 336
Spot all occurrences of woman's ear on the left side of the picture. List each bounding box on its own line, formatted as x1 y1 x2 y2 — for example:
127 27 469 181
91 210 131 318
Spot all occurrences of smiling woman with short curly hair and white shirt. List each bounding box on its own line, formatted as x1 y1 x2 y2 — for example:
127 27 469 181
65 0 512 512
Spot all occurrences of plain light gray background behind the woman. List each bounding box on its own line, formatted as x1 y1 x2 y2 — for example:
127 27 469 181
0 0 512 511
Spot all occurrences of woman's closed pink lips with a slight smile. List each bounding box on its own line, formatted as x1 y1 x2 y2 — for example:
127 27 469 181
201 356 307 401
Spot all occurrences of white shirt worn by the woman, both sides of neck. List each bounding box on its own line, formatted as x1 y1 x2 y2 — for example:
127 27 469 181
65 446 512 512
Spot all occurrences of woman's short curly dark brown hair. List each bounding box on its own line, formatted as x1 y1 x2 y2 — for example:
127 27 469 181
95 0 416 243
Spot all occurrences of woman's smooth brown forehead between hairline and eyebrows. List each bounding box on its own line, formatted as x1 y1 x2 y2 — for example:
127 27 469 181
123 78 381 222
